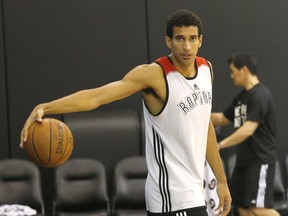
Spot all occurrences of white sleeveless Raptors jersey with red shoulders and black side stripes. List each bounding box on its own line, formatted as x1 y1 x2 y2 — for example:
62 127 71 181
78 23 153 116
143 57 212 213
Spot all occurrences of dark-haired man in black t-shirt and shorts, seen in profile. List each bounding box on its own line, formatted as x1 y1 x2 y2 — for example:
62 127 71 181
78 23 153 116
211 52 279 216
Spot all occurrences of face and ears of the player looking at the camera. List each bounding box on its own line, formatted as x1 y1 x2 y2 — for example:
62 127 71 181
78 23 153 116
166 26 202 64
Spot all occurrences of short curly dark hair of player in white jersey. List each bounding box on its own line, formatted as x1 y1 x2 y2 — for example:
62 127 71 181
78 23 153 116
166 9 202 38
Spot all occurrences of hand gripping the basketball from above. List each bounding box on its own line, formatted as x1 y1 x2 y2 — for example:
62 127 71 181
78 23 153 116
20 106 44 148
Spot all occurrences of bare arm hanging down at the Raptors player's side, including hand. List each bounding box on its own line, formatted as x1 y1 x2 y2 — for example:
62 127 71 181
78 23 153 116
206 121 232 216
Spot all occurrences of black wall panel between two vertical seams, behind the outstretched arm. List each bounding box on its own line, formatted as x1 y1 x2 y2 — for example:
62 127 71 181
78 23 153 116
4 0 147 157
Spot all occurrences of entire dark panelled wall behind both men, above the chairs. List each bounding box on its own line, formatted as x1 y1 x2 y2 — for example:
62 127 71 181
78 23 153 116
0 0 288 162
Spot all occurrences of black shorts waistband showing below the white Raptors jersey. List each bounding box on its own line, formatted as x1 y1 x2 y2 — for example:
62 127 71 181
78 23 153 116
147 206 208 216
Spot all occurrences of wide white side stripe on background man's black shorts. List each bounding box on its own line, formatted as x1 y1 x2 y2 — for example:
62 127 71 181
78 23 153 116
256 164 269 208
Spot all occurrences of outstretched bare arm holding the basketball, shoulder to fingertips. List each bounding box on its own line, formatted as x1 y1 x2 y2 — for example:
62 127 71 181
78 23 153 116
20 63 162 147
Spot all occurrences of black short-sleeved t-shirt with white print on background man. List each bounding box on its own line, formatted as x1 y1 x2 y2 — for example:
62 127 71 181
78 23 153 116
224 83 277 166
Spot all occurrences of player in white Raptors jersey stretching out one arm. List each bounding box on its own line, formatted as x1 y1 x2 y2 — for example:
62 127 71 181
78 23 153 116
21 10 231 216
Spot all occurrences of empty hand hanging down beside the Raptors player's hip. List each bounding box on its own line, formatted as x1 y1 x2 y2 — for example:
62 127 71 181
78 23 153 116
216 183 232 216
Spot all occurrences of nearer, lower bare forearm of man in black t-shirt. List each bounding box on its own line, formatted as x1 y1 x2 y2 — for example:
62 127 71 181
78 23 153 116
219 120 259 149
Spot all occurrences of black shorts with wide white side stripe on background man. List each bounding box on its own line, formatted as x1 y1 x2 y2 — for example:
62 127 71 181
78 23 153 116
231 163 275 208
